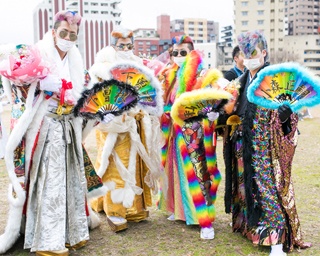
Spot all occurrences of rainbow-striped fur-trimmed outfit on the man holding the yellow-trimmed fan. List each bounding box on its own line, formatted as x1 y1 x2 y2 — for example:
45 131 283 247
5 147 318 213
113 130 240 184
159 51 222 227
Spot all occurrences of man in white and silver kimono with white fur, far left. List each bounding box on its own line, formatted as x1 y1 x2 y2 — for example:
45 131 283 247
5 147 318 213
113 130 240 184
0 11 102 255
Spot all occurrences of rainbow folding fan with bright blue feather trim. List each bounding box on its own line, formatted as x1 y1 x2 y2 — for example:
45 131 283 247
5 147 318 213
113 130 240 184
247 63 320 112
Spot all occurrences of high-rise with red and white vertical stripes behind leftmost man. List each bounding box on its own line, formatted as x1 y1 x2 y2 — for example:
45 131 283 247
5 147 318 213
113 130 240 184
34 0 121 68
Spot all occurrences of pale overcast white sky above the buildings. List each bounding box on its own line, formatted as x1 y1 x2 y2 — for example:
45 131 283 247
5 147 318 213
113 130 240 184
0 0 233 44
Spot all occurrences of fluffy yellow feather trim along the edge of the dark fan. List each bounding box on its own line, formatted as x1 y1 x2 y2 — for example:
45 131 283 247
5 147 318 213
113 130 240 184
171 88 232 127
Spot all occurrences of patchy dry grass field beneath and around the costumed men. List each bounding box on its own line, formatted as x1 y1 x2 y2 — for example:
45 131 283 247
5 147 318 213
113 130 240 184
0 104 320 256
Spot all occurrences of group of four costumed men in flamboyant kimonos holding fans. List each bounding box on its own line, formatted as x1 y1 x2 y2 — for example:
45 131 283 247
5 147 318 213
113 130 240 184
0 11 320 255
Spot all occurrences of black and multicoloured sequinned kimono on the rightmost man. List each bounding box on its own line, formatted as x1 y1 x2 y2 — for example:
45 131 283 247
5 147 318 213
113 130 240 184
224 67 309 251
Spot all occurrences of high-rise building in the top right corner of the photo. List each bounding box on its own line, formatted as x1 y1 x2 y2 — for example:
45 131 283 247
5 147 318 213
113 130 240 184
284 0 320 36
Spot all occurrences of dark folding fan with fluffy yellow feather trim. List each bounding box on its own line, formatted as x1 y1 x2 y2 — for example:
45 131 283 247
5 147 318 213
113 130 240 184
171 88 232 126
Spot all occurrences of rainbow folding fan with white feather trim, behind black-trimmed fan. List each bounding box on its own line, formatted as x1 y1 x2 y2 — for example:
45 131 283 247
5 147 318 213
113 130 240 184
110 62 163 116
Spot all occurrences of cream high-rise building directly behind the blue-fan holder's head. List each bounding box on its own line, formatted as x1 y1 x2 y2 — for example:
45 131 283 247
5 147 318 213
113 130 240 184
234 0 284 60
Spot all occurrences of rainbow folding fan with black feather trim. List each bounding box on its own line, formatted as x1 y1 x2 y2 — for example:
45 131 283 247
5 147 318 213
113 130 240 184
74 79 139 120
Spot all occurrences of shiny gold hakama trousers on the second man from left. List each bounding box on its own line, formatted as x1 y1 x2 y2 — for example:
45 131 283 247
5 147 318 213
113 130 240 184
91 117 152 221
